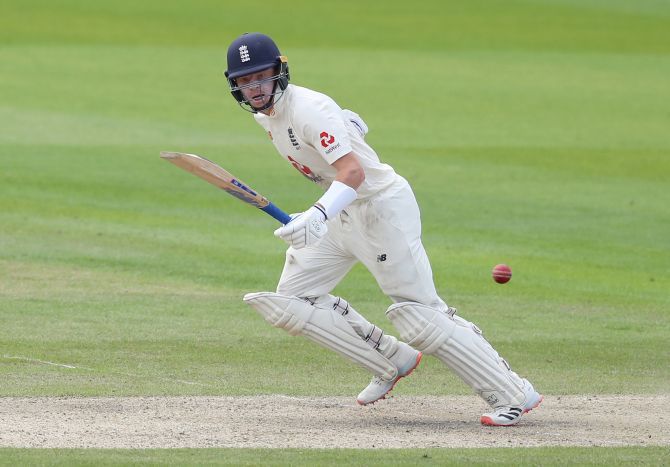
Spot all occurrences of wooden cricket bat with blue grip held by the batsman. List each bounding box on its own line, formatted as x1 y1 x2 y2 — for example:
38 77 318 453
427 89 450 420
161 151 291 224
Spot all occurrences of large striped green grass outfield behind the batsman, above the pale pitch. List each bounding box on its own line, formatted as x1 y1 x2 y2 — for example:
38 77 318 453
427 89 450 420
0 0 670 463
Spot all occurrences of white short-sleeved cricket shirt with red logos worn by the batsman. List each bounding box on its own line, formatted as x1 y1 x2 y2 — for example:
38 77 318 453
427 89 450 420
254 84 396 200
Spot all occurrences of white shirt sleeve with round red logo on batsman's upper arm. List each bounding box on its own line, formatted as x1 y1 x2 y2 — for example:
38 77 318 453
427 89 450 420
295 94 352 164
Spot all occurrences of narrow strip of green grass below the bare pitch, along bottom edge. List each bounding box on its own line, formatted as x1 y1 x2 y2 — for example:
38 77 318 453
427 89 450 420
0 447 670 466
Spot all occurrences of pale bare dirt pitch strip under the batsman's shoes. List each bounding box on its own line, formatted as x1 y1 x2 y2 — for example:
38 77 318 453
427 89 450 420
0 395 670 448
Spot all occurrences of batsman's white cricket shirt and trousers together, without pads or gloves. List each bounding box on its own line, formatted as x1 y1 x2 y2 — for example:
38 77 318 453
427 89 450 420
254 84 448 311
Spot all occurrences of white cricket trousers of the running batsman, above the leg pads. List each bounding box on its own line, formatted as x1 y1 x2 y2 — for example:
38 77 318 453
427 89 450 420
277 175 448 311
